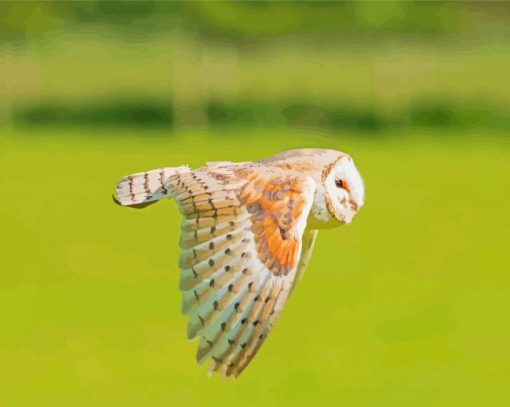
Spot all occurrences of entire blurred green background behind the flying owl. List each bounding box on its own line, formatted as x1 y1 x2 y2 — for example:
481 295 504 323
0 1 510 407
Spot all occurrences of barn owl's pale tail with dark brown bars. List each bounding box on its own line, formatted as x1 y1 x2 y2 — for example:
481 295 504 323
113 166 190 208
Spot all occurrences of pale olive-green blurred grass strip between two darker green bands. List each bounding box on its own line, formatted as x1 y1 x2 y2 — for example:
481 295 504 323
5 33 510 110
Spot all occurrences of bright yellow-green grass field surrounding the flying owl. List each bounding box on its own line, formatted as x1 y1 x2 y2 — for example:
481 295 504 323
0 129 510 407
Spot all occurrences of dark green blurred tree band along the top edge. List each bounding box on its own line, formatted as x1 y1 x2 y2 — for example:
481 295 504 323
0 0 510 44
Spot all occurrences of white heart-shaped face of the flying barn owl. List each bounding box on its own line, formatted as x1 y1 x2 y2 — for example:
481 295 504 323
316 154 365 226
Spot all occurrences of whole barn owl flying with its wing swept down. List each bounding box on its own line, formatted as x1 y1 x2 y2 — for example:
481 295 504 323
114 149 365 377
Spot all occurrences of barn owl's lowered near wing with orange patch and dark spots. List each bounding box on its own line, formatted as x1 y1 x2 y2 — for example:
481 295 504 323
170 165 315 376
